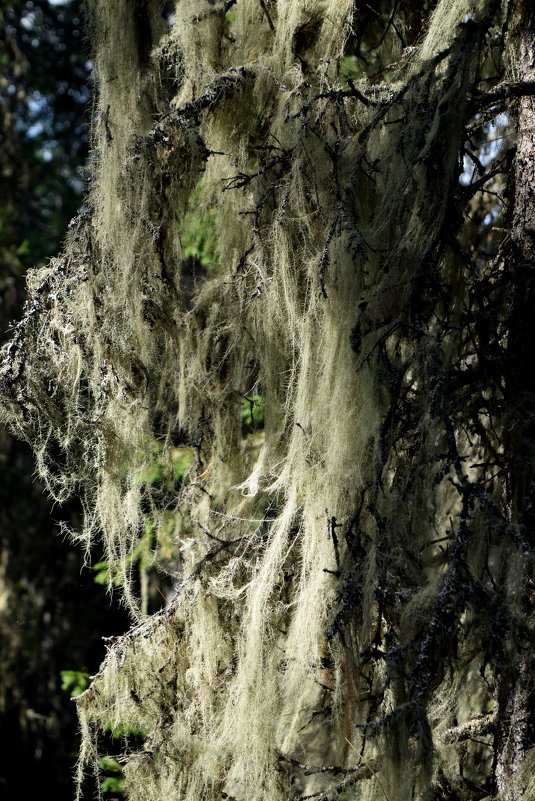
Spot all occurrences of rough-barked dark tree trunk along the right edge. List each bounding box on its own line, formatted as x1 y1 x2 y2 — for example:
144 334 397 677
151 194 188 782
494 3 535 801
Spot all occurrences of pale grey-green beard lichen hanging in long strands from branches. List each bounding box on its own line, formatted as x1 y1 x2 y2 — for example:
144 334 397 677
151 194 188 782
2 0 532 801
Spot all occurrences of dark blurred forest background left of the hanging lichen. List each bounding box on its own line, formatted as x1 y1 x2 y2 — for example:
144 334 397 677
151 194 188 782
0 0 128 801
